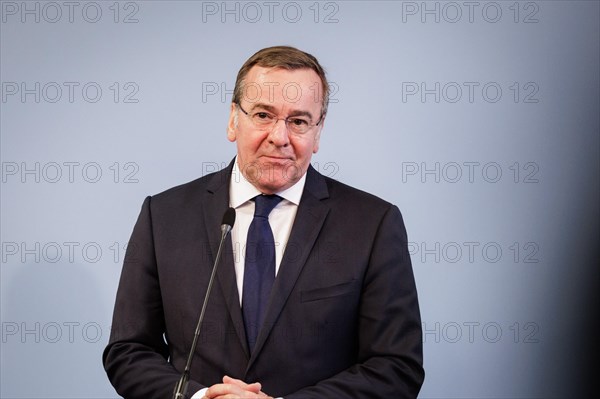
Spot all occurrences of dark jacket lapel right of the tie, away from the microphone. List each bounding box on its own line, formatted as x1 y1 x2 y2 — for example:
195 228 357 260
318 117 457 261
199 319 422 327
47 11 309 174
248 166 329 369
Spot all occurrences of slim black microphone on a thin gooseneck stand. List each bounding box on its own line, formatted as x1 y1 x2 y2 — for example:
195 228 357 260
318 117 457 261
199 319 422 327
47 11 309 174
173 208 235 399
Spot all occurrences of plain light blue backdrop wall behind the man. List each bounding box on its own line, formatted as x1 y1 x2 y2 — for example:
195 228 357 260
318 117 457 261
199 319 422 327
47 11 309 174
0 1 600 398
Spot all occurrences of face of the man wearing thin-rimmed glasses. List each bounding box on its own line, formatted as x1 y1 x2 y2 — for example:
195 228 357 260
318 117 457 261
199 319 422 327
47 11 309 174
227 66 323 194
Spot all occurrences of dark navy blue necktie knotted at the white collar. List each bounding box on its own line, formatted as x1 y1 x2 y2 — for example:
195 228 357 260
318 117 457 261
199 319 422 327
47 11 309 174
242 195 282 351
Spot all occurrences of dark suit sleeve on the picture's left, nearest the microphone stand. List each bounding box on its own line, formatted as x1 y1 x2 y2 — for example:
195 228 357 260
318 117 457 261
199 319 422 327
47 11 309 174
103 197 202 399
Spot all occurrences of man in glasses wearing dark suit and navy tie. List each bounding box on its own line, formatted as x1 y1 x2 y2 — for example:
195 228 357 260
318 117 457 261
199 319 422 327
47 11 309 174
103 46 424 399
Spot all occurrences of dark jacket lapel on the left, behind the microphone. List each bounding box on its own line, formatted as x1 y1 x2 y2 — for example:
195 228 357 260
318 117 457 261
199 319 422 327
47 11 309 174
204 161 249 357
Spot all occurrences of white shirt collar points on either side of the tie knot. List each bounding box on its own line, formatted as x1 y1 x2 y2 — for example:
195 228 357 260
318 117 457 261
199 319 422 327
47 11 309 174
229 157 306 208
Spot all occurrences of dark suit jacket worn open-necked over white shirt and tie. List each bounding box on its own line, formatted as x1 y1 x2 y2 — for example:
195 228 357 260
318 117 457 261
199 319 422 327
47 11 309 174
103 161 424 399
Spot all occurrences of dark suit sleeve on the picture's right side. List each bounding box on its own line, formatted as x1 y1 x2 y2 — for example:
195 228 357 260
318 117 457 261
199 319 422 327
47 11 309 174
284 206 425 399
